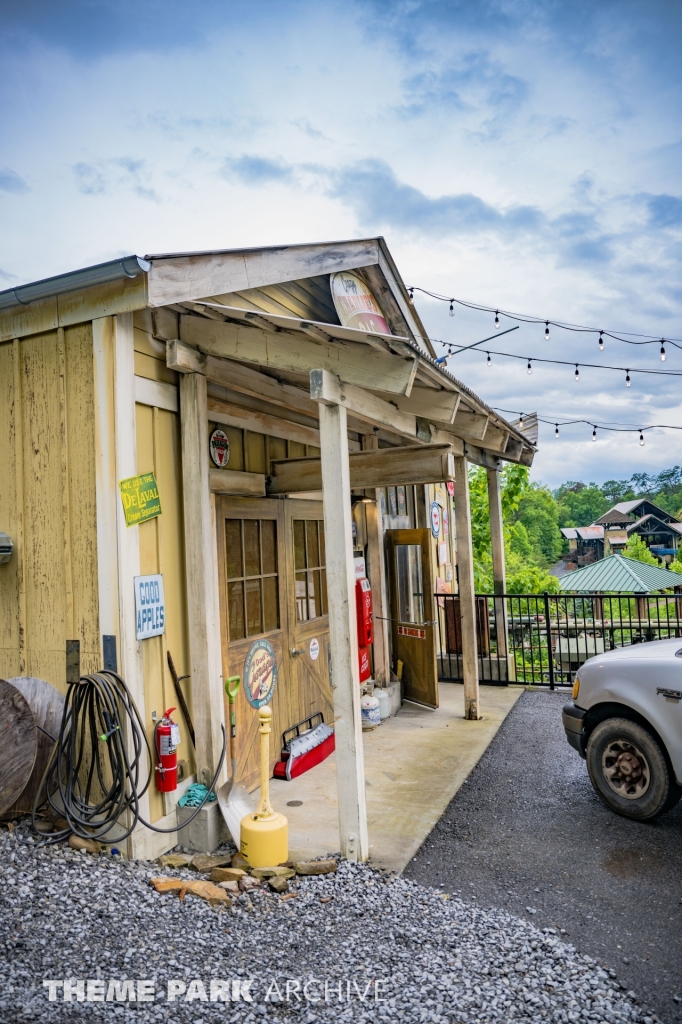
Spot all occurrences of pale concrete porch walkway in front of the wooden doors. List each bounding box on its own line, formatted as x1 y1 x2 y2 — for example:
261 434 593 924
270 683 523 871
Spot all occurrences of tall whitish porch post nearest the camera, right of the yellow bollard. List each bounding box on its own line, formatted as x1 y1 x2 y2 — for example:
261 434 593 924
313 385 369 860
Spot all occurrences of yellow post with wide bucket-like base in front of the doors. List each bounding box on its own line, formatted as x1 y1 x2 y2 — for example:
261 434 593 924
240 705 289 867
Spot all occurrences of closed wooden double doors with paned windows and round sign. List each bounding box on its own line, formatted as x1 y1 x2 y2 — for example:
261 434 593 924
216 496 334 790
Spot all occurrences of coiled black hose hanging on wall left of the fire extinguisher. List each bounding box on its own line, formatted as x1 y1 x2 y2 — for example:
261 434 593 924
32 671 226 845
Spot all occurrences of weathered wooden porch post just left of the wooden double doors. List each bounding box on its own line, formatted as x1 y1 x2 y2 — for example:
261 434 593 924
180 373 226 787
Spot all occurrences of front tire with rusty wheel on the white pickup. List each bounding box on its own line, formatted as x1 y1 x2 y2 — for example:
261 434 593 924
586 718 682 821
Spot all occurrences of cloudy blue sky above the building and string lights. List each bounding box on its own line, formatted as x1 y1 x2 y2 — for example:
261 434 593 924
0 0 682 486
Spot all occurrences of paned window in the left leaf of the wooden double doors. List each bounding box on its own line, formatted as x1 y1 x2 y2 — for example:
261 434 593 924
225 519 280 641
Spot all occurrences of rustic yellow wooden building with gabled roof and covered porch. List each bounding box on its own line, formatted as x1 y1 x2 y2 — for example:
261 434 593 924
0 239 535 859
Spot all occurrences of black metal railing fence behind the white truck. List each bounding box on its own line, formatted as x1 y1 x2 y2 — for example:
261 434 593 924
434 594 682 689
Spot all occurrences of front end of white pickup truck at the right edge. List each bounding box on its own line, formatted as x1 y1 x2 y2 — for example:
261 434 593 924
563 638 682 821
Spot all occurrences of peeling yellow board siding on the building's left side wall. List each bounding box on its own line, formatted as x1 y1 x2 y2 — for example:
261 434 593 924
0 324 99 691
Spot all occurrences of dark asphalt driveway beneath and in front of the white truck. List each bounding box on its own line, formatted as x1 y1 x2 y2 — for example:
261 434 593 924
406 691 682 1024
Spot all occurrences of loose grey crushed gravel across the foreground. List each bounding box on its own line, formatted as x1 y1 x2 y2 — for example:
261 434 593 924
0 831 651 1024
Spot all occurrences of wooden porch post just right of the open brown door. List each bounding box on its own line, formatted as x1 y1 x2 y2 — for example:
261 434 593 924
455 456 480 720
